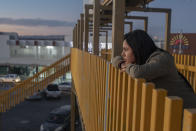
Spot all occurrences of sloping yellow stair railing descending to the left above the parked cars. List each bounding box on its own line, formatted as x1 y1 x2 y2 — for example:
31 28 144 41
0 55 70 112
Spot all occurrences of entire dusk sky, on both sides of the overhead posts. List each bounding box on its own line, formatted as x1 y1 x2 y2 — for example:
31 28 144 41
0 0 196 41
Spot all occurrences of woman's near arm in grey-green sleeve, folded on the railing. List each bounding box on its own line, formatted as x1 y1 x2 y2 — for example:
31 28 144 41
126 53 174 81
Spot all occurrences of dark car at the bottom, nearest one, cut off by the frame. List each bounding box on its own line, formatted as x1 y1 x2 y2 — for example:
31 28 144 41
40 105 71 131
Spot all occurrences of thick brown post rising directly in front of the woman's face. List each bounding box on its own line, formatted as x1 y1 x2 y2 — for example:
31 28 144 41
112 0 125 57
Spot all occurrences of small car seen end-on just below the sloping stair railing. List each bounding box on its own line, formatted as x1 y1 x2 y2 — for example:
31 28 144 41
45 84 61 98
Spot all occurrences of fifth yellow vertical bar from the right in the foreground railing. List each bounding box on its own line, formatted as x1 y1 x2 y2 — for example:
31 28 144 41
132 79 145 131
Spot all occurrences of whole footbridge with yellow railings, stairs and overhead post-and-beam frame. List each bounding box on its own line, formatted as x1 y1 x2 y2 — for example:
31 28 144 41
0 0 196 131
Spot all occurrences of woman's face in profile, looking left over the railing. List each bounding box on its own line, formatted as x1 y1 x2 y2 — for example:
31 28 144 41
121 40 135 64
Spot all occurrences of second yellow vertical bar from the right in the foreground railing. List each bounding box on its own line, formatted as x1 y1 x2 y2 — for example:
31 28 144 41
163 96 183 131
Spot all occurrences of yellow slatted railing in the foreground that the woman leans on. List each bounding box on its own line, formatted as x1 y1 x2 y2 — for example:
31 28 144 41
71 49 196 131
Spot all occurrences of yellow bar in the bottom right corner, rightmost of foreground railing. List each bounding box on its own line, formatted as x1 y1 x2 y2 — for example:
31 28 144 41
183 109 196 131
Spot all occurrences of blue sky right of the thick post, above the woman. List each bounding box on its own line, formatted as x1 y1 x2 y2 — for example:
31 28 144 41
127 0 196 38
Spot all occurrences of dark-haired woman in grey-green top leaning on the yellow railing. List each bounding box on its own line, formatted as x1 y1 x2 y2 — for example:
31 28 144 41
112 30 196 108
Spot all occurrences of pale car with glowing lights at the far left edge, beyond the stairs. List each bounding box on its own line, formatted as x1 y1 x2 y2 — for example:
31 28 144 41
0 74 21 82
